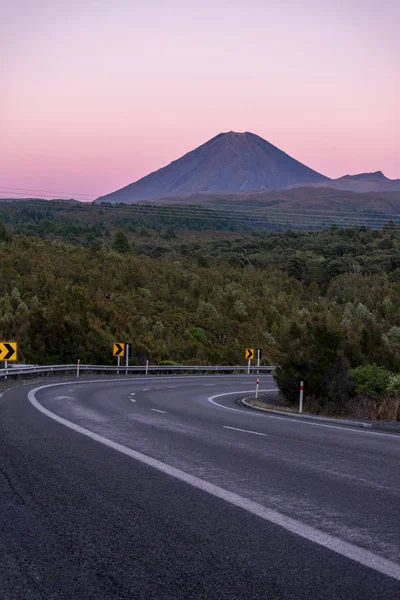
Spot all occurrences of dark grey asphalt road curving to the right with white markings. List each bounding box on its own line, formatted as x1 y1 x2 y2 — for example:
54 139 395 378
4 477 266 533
0 376 400 600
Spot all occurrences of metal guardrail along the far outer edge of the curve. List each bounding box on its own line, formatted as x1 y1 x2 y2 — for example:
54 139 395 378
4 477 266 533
0 364 276 379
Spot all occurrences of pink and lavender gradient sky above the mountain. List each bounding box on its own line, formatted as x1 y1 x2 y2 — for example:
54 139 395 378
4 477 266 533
0 0 400 199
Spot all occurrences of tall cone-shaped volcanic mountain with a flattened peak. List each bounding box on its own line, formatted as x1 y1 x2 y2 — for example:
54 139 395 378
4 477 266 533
95 131 329 203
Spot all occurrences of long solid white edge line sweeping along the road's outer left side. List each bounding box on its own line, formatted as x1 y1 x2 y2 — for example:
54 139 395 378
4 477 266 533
28 381 400 581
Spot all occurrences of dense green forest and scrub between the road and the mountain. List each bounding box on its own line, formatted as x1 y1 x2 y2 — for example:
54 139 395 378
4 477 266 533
0 202 400 419
